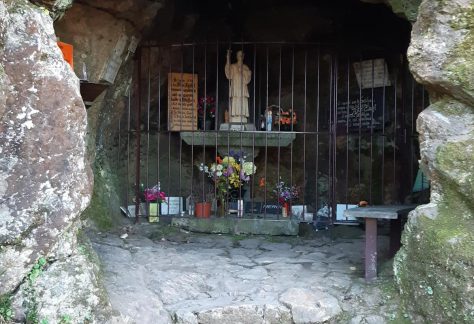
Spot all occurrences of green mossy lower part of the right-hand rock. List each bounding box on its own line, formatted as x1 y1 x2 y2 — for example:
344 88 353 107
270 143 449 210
394 132 474 323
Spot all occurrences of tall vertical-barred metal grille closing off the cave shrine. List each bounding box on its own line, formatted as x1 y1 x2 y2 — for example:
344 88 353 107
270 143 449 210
117 42 428 223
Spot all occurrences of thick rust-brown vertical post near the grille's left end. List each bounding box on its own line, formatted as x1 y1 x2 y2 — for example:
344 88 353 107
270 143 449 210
135 49 142 223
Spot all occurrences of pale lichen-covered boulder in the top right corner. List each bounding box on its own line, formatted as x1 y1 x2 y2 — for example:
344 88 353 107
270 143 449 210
408 0 474 107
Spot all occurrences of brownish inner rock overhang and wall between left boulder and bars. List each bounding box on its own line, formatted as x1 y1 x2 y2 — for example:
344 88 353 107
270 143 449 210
55 0 163 228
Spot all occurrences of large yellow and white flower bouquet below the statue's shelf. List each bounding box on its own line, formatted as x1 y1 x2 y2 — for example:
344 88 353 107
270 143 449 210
199 154 257 215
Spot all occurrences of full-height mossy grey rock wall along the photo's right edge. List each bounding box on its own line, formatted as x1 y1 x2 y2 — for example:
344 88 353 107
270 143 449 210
395 0 474 323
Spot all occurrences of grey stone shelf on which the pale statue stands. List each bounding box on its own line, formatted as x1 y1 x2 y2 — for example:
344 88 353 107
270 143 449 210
180 131 296 161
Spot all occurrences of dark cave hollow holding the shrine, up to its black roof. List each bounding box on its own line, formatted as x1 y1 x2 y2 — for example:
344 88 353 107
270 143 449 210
115 0 428 226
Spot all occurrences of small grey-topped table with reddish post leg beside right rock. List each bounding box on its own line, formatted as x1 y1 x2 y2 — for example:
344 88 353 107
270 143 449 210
344 205 417 281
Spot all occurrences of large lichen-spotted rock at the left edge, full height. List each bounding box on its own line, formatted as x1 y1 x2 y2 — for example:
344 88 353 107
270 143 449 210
0 0 109 322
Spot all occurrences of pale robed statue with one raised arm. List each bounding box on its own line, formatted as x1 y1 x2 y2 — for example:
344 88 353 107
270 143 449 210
225 50 252 124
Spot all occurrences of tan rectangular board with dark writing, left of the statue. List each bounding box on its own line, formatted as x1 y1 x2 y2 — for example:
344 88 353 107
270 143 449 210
168 72 198 132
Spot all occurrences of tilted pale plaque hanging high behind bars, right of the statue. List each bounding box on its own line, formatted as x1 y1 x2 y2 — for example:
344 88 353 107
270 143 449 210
353 59 392 89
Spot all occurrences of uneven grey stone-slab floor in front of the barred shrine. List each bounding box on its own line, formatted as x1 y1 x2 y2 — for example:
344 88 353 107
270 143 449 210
89 224 406 324
